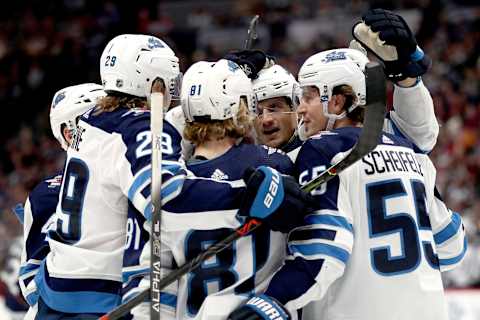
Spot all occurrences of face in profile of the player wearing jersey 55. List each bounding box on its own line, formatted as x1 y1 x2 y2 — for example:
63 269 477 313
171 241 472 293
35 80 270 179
297 87 328 137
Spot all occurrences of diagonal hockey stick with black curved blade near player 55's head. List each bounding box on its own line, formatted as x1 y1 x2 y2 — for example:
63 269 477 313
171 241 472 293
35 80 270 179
100 62 386 320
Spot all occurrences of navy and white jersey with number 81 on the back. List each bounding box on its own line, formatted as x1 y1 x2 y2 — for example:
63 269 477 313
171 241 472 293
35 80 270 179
158 143 293 319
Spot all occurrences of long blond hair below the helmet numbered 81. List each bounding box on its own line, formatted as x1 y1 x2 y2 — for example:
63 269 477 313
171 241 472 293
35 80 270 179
183 98 252 146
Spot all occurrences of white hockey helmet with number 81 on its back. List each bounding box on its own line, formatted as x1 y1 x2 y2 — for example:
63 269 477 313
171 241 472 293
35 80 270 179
181 59 256 122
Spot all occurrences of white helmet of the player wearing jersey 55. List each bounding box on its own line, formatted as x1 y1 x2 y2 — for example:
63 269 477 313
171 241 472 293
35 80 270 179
298 48 368 107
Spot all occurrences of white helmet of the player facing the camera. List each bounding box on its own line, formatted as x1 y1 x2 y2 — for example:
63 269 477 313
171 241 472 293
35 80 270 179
252 64 301 110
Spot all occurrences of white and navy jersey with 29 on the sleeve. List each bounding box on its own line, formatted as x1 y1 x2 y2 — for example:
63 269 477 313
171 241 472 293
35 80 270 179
35 107 185 313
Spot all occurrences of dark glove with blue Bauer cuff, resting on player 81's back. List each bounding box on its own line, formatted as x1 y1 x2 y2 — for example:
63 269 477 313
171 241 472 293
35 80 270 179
238 166 313 233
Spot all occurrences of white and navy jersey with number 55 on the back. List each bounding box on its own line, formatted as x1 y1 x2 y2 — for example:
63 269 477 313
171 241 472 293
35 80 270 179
266 127 466 320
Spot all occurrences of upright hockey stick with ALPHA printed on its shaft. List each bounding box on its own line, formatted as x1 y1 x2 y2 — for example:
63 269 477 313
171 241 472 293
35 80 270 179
150 85 164 320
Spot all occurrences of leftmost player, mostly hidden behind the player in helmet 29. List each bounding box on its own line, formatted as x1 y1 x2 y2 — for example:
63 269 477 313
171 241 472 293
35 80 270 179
16 83 105 316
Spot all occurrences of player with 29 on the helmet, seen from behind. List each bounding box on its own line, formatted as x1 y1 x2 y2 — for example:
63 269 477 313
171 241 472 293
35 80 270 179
28 35 186 319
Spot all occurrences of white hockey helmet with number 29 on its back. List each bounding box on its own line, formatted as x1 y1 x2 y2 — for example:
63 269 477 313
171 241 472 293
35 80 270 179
100 34 181 104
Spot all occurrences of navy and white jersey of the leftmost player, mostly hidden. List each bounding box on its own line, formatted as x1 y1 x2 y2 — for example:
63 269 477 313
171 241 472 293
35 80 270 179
15 173 62 305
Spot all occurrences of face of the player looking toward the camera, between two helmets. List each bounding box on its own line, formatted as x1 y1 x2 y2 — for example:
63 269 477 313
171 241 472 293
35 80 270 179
254 97 297 148
